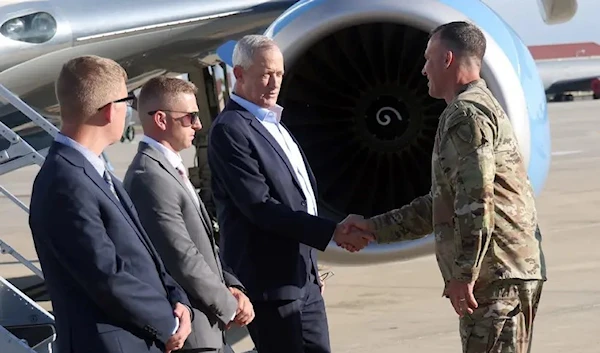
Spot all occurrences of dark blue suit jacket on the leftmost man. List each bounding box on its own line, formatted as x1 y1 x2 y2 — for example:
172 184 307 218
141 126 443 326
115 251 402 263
29 142 189 353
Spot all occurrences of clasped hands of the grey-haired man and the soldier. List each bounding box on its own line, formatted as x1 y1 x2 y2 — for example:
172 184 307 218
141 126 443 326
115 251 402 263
333 214 375 252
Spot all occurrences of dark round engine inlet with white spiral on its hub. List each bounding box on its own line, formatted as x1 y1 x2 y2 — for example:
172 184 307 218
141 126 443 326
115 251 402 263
280 22 446 219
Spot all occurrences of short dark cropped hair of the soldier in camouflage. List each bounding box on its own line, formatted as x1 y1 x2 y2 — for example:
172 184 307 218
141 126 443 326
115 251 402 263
429 21 486 62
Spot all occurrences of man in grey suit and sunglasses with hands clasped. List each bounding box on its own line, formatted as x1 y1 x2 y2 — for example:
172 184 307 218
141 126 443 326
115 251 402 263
123 76 254 352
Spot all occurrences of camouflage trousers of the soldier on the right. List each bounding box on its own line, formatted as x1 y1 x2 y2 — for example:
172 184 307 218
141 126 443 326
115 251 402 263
460 280 543 353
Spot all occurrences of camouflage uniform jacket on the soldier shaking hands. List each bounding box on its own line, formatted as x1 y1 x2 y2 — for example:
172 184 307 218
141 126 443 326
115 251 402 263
371 79 546 288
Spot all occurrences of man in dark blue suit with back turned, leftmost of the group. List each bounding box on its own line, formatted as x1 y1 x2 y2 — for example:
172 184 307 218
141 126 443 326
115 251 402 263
29 56 192 353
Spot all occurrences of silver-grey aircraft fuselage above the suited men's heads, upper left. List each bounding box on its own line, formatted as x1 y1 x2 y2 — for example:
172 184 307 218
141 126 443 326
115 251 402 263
0 0 296 114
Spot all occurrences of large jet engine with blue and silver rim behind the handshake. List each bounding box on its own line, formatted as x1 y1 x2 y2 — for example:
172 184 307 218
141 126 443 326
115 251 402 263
219 0 550 264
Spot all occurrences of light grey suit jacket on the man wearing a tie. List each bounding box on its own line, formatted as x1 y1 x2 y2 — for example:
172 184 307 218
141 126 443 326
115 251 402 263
123 142 243 349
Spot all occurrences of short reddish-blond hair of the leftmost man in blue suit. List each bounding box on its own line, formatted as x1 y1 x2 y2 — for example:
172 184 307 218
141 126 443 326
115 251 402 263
55 55 127 122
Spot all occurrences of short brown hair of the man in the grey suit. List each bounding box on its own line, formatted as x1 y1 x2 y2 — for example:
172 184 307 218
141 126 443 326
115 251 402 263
138 76 198 117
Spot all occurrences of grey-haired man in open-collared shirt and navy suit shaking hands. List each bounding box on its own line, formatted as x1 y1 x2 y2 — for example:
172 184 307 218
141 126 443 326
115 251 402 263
208 35 373 353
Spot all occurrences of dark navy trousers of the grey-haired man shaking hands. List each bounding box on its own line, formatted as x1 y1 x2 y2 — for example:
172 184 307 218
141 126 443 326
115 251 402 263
248 283 331 353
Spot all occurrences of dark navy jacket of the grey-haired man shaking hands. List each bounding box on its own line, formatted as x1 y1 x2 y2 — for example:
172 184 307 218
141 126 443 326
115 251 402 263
208 100 336 300
